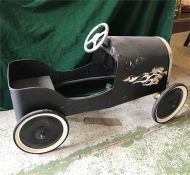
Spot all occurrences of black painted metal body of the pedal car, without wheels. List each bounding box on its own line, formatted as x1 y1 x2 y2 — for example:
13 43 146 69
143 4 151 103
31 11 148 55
8 36 171 120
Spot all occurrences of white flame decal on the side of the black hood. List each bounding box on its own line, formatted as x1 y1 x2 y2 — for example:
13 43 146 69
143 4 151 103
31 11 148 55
123 67 167 86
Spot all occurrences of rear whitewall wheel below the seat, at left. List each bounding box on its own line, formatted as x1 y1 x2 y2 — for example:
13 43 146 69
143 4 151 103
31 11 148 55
13 110 69 154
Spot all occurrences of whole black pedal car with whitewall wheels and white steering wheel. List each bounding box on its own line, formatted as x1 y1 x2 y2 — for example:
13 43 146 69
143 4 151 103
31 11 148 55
8 23 187 153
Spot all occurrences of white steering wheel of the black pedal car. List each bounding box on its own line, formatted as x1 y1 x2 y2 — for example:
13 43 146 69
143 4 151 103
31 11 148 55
84 23 109 53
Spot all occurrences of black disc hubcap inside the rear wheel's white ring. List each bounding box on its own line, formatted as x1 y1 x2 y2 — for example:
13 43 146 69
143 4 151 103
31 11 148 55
20 116 63 148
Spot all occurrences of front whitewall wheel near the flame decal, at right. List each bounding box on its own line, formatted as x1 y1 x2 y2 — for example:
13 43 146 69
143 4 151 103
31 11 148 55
152 83 188 123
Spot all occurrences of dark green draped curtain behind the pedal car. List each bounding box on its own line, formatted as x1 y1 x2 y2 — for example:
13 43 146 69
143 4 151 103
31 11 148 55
0 0 175 110
